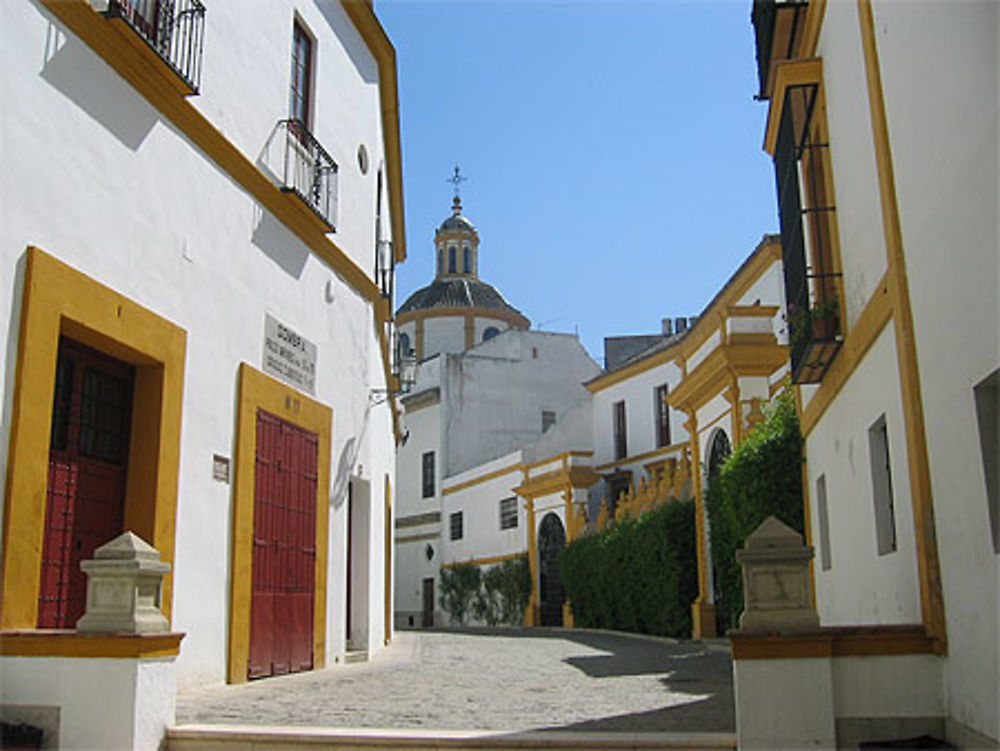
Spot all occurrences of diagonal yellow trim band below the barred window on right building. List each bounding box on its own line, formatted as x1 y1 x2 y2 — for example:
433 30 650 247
800 274 892 436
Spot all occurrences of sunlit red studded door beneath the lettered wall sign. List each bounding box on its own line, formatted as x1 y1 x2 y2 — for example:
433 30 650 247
248 410 319 678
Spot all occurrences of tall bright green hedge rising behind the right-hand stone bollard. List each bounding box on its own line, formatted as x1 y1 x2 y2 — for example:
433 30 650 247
705 389 803 627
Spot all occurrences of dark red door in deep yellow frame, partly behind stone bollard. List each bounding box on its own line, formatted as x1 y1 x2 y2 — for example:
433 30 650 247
38 339 133 628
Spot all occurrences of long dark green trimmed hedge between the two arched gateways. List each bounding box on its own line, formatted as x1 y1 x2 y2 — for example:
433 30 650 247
559 501 698 637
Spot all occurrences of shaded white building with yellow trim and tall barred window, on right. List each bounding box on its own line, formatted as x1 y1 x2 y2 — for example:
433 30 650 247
734 0 1000 748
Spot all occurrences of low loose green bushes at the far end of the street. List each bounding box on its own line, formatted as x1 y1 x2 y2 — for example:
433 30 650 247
441 555 531 626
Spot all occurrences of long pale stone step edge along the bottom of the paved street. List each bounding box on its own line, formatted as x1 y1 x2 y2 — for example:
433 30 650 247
165 725 736 751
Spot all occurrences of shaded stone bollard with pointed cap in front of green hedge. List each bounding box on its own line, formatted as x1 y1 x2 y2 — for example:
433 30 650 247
736 516 819 633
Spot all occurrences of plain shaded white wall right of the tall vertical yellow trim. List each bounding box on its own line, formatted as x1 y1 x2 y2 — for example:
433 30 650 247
874 0 1000 739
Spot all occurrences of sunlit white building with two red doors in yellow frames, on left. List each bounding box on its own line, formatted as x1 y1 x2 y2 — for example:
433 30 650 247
0 0 405 712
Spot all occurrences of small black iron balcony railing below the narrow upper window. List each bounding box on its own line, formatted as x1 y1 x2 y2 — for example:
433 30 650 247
278 119 337 232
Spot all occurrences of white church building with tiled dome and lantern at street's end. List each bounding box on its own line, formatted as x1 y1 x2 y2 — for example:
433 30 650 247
395 197 599 626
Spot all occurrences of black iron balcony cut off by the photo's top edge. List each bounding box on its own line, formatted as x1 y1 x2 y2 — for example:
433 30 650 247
104 0 205 94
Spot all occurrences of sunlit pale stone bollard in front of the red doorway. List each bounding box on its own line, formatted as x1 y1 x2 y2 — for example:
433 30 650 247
76 532 170 634
